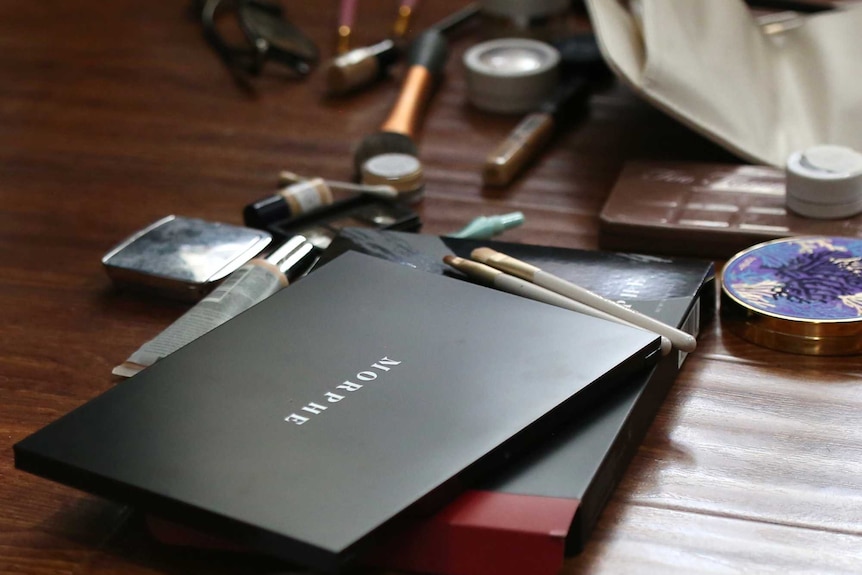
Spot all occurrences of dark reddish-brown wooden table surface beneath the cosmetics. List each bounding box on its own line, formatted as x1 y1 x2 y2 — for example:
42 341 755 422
0 0 862 575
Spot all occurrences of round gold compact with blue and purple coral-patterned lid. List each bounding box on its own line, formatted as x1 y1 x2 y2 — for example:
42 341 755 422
721 236 862 355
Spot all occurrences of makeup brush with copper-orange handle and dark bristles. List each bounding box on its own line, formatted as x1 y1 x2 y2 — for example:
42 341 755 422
353 28 449 176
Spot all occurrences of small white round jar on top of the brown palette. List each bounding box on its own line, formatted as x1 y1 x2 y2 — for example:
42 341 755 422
785 145 862 219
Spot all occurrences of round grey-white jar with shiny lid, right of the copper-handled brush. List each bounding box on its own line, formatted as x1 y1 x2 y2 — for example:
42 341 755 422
464 38 560 114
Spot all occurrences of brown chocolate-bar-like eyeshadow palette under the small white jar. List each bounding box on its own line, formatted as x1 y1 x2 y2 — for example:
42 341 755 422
599 162 862 259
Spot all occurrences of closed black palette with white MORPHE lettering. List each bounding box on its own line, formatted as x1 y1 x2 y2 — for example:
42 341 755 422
15 253 659 572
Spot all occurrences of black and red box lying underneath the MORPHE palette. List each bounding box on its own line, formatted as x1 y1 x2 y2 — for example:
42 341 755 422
318 229 715 575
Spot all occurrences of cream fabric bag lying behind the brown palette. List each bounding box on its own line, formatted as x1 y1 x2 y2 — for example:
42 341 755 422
587 0 862 166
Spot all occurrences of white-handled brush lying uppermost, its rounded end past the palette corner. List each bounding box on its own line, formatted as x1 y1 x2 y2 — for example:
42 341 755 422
470 248 697 352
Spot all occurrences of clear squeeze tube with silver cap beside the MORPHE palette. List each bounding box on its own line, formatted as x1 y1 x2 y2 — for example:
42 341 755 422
112 236 315 377
